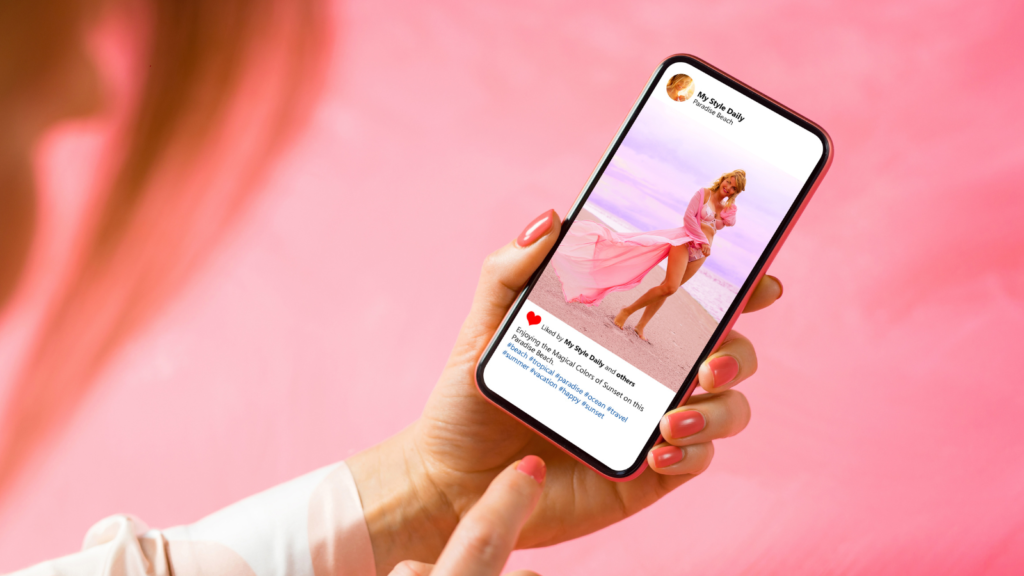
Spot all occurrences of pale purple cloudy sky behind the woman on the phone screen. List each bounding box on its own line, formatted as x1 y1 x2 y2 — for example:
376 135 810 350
587 98 803 287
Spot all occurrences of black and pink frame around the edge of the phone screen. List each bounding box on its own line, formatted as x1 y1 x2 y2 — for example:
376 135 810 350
475 54 833 481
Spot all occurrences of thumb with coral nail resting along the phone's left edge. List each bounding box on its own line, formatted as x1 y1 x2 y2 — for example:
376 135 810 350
450 210 561 363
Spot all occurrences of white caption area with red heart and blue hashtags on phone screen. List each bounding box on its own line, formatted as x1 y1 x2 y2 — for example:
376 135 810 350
484 297 674 469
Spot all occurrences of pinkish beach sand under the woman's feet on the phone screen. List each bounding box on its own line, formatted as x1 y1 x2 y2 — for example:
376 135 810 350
528 210 718 392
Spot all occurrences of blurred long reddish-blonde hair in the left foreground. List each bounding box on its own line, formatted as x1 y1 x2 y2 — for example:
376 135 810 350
0 0 331 503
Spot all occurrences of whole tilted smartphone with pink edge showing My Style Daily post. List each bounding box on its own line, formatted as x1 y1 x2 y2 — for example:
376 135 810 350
476 54 833 481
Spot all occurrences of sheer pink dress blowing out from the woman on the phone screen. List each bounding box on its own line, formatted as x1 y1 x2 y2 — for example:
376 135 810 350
551 189 736 305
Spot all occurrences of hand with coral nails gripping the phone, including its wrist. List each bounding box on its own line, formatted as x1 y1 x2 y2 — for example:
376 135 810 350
348 207 782 574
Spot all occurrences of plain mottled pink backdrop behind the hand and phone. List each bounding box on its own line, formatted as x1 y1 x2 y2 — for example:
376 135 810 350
0 0 1024 575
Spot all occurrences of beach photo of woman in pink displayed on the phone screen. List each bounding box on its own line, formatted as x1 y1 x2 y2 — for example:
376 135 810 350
527 88 802 390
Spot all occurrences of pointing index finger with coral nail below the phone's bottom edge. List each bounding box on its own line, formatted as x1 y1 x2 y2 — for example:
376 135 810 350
431 456 547 576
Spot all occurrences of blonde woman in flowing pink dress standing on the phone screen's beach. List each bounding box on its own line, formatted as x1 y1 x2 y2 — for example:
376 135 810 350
551 170 746 341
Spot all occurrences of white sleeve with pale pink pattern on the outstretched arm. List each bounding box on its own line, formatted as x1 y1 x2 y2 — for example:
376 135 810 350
6 462 376 576
